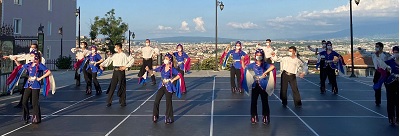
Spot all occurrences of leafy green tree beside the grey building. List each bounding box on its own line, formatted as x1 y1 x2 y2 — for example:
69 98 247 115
90 9 128 44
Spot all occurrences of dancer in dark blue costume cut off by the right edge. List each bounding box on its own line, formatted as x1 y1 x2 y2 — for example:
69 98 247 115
385 46 399 125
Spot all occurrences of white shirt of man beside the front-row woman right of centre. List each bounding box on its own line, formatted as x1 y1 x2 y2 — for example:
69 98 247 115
279 57 306 74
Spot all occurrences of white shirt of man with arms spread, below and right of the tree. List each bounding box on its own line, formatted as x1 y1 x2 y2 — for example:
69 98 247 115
100 52 135 67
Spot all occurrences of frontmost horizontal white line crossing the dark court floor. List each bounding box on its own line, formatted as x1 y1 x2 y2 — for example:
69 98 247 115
0 114 384 118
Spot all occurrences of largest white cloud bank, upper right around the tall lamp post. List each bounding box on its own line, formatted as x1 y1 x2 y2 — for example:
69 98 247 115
266 0 399 35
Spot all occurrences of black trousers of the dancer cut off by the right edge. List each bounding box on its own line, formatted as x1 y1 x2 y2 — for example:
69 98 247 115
386 80 399 122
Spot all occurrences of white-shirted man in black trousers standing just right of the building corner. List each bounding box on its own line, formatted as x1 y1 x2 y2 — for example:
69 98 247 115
71 43 91 86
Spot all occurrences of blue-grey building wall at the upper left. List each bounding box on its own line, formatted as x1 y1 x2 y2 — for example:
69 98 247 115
0 0 77 60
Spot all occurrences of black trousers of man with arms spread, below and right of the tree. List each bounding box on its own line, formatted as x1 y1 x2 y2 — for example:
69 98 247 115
107 70 126 105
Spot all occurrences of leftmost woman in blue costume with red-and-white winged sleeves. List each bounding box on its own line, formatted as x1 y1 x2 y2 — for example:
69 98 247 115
7 51 56 124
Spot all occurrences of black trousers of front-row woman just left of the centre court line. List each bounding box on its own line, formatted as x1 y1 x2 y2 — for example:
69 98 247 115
153 86 174 121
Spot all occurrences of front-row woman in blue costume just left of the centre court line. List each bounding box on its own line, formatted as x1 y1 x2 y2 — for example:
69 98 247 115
153 54 186 124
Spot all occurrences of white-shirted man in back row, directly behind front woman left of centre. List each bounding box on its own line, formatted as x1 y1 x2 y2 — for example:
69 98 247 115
137 39 157 85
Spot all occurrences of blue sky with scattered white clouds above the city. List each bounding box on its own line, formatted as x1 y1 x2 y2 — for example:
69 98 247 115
77 0 399 40
